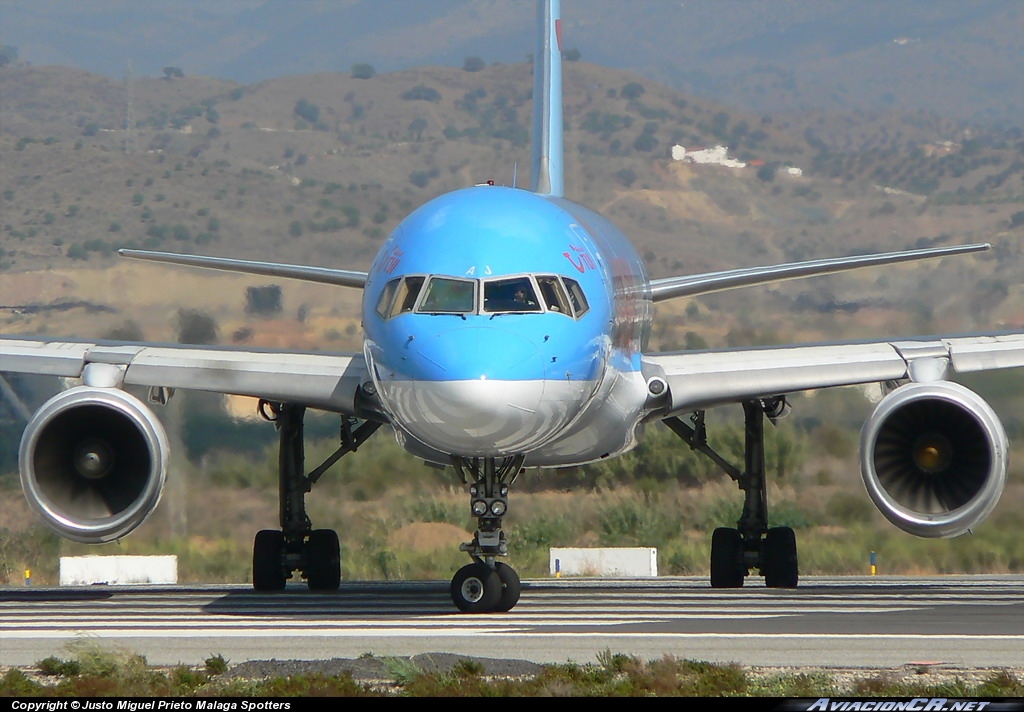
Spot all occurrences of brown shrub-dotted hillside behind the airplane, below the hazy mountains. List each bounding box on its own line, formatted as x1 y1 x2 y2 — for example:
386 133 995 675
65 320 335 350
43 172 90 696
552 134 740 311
0 61 1024 354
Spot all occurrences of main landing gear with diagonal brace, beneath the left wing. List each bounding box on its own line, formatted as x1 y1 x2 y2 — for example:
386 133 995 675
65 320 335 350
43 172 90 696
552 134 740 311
253 401 381 591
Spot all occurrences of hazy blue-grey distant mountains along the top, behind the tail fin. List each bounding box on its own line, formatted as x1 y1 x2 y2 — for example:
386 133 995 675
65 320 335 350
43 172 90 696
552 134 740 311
0 0 1024 126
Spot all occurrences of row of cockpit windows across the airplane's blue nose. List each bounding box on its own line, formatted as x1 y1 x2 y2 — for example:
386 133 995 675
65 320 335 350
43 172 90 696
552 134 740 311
377 275 590 319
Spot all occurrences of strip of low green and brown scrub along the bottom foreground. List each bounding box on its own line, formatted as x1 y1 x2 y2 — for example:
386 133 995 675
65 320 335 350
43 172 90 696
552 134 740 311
0 638 1024 698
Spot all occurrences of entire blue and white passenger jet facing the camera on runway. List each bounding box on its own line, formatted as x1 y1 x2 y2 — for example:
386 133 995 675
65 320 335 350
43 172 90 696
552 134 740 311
0 0 1024 614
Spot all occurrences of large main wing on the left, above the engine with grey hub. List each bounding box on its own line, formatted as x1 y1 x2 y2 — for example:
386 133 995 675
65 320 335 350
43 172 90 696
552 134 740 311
0 337 371 415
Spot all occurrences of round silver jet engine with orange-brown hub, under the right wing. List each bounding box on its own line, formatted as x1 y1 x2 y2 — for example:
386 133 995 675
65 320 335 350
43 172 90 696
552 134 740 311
860 381 1008 538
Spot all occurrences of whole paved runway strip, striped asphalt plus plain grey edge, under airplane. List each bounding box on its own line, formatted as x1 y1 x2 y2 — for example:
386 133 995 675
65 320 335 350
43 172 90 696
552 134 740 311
0 575 1024 668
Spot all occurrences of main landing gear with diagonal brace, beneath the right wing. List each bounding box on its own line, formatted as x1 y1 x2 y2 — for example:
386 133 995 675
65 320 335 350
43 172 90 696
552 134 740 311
663 397 799 588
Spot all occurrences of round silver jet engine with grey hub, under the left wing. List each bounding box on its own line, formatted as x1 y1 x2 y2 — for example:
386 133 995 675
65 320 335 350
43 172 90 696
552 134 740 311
18 386 168 544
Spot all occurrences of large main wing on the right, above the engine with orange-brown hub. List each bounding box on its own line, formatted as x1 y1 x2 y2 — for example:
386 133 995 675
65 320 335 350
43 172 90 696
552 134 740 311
643 332 1024 415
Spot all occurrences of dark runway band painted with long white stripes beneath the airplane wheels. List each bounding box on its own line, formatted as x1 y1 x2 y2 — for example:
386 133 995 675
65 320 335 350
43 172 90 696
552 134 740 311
0 579 1024 644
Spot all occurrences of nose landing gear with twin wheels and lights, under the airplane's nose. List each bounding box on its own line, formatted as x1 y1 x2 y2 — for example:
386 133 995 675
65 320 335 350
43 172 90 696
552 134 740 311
452 455 523 613
